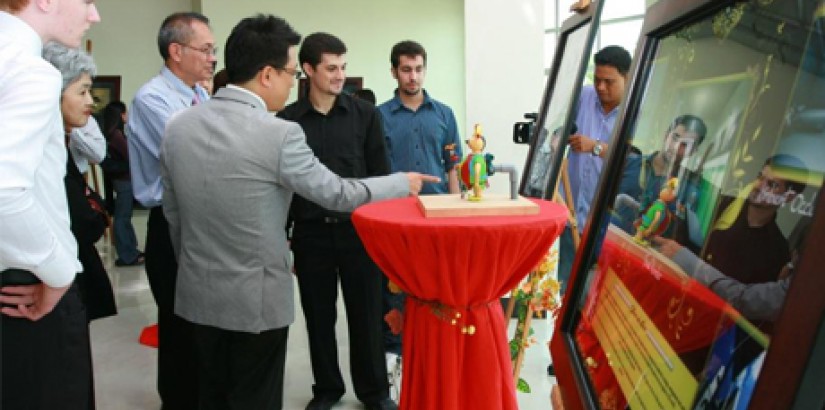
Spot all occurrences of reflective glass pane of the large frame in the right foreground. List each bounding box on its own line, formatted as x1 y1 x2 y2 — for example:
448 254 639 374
574 2 825 408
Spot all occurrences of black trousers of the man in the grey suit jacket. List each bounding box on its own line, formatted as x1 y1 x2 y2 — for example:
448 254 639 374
195 324 289 410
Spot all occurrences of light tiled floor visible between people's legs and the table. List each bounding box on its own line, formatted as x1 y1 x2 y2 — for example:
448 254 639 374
91 211 555 410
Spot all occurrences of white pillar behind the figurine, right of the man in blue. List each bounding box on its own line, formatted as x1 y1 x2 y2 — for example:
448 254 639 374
464 0 545 193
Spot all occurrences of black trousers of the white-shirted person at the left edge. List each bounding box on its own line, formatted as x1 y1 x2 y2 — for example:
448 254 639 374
0 284 94 410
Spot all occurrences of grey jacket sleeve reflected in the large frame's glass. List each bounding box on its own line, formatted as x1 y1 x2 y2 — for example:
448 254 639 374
673 248 793 321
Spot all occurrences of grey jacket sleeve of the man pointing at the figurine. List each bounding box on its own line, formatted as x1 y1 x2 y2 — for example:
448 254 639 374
276 122 409 212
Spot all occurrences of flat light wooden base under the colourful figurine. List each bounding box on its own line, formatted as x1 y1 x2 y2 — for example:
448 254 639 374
418 194 539 218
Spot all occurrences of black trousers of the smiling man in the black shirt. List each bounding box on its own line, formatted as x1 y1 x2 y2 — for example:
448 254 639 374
292 221 389 404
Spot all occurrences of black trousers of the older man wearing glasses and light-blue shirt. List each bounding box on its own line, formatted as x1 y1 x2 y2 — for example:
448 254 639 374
145 207 198 410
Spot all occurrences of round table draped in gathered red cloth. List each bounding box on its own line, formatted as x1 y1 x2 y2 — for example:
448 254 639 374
352 198 567 410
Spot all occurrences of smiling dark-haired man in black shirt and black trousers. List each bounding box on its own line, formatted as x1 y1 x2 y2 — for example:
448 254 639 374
278 33 397 410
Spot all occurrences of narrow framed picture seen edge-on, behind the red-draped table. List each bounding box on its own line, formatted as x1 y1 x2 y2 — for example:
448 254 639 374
519 1 604 199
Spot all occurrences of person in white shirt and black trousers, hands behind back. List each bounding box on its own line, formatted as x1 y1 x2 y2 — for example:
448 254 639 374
0 0 100 410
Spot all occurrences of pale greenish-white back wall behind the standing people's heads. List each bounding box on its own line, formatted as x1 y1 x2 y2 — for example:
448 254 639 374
87 0 465 128
